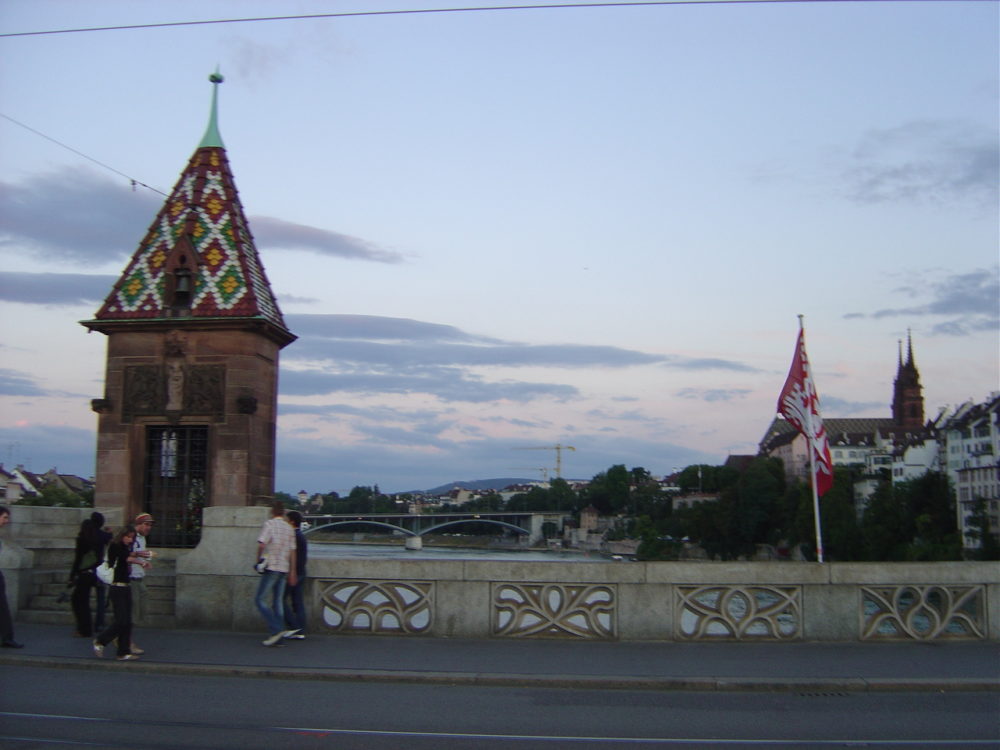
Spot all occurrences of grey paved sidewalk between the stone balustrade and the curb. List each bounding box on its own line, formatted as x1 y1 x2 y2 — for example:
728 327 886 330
0 623 1000 692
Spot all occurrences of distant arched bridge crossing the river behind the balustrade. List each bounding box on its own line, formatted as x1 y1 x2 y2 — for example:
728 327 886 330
305 511 572 549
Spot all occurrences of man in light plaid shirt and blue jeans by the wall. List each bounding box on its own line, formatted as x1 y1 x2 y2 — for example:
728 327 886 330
254 501 298 646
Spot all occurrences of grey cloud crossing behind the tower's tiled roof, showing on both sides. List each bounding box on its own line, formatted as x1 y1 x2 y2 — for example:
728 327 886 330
0 167 403 268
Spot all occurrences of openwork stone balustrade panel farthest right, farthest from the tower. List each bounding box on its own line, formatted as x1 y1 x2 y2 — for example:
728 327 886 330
861 585 986 641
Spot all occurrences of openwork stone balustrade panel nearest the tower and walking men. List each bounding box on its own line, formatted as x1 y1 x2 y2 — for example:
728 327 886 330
316 579 434 635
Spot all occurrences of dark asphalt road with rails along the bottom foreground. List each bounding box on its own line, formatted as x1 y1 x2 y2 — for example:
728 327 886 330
0 664 1000 750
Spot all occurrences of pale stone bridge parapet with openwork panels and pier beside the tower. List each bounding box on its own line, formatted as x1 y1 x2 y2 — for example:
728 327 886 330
177 508 1000 641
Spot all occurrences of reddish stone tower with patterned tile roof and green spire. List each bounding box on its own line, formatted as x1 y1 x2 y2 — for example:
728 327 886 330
82 74 296 546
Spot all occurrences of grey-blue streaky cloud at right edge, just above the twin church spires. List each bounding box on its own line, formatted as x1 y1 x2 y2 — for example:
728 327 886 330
844 266 1000 336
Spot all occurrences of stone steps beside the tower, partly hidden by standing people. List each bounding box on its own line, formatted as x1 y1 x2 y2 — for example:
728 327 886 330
17 550 177 631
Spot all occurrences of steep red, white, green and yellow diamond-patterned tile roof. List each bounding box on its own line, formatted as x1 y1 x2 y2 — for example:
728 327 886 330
96 142 291 335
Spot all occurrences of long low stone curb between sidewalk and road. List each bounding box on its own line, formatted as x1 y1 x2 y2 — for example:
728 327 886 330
0 655 1000 693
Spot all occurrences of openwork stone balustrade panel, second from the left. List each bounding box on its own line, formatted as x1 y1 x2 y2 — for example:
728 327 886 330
490 583 618 639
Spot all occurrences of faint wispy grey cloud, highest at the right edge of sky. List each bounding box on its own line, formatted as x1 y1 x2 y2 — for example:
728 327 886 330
845 120 1000 206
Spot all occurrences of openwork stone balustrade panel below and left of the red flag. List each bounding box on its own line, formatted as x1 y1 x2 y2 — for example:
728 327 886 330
676 586 802 641
